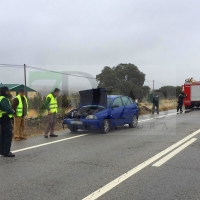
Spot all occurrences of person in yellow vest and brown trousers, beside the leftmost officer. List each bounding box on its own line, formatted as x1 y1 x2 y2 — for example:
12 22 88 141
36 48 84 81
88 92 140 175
12 89 28 141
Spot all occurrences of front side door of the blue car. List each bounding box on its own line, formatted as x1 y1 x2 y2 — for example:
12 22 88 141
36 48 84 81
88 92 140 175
111 97 124 126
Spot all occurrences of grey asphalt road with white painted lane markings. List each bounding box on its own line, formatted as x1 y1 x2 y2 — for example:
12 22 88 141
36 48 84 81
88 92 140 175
0 110 200 200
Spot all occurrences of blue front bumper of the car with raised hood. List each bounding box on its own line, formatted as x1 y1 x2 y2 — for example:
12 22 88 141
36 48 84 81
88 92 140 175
63 119 101 130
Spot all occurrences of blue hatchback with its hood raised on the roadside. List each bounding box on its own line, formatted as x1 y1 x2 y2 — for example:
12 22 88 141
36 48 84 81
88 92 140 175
63 88 138 133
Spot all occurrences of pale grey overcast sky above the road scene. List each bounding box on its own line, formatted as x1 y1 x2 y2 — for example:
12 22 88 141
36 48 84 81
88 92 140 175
0 0 200 90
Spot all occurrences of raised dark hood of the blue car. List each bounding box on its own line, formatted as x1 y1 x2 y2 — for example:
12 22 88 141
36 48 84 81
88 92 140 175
79 88 107 108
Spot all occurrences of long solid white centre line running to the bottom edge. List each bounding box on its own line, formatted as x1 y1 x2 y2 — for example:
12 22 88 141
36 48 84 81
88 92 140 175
82 129 200 200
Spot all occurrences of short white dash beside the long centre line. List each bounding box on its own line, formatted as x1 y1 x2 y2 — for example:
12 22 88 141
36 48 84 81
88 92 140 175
152 138 197 167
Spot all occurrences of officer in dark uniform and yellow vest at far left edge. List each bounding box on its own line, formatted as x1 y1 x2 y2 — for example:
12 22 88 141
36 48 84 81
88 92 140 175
0 87 15 157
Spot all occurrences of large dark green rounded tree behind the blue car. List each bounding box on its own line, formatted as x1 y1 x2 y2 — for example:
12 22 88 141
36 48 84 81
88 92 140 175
96 63 150 101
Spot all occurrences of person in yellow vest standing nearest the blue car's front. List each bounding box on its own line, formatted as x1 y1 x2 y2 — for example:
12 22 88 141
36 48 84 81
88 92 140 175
44 88 60 138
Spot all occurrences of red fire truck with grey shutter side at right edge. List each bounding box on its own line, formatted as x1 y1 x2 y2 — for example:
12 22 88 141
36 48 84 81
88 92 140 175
183 81 200 109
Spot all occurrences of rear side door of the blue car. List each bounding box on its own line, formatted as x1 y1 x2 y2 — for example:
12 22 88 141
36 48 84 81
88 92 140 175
122 96 135 123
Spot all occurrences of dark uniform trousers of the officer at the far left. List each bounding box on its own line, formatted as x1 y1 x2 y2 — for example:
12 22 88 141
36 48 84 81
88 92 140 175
0 119 12 155
